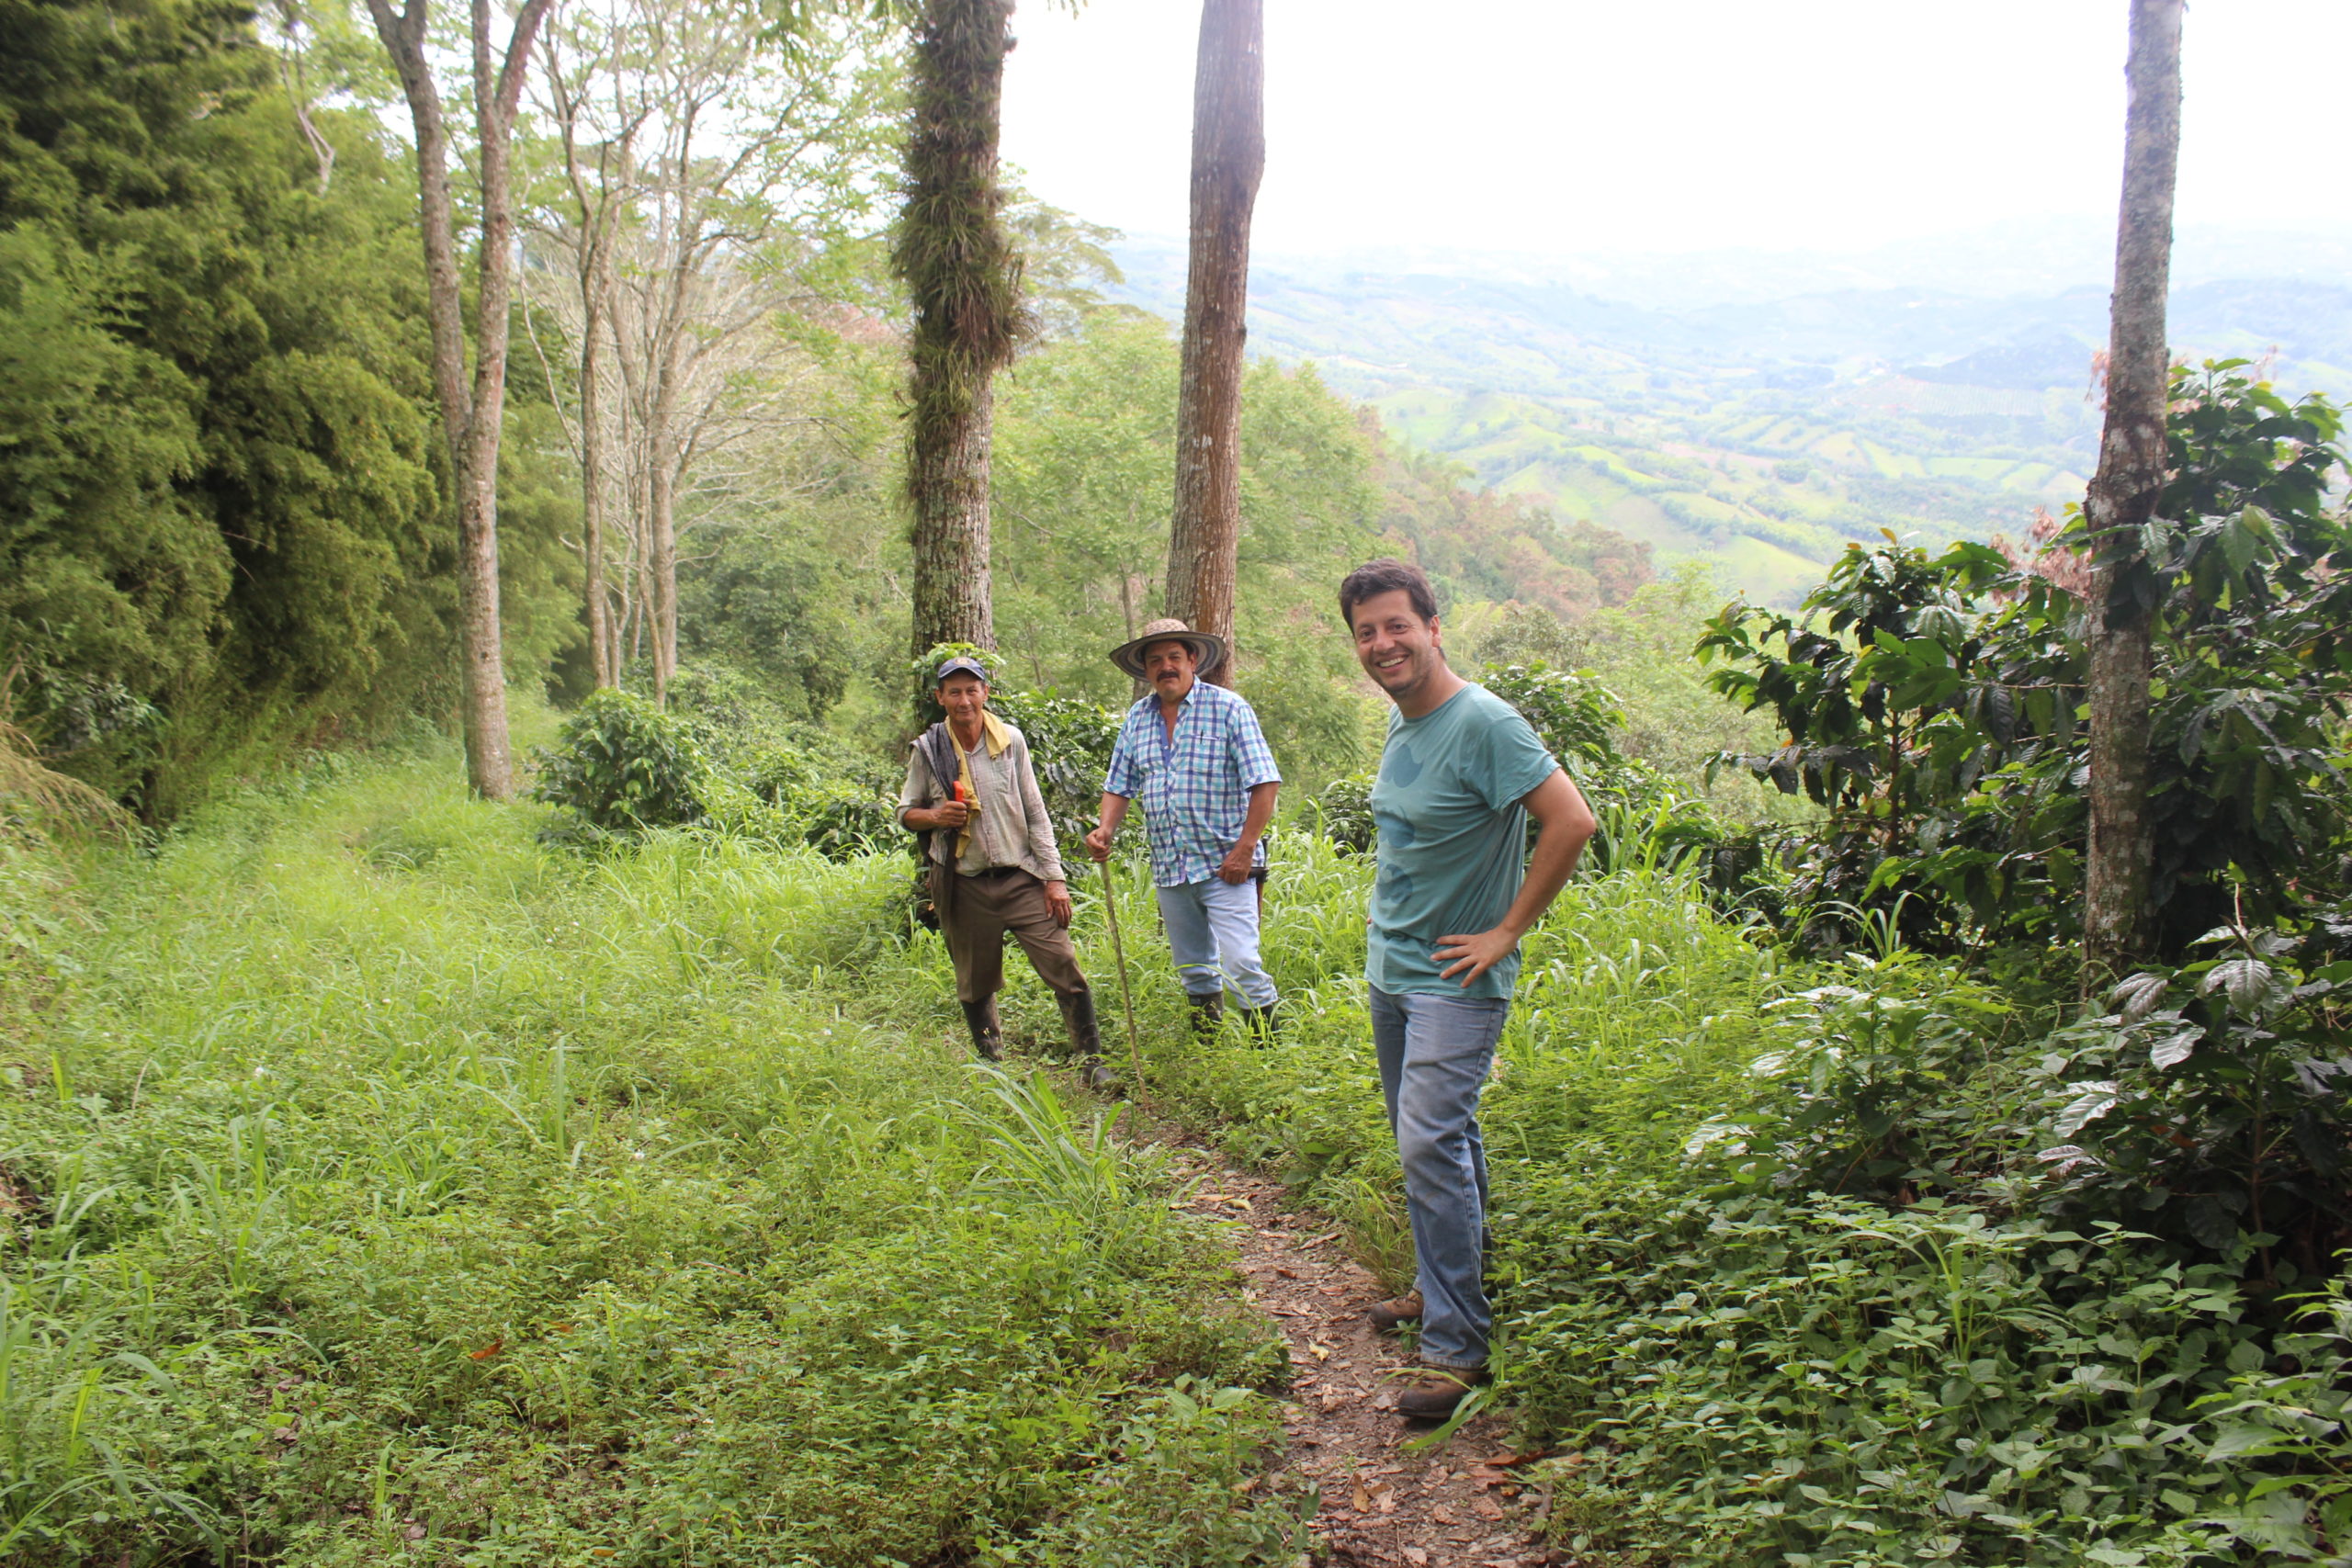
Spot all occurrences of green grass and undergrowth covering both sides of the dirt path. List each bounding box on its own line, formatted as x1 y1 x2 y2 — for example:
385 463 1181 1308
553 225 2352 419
0 738 2352 1568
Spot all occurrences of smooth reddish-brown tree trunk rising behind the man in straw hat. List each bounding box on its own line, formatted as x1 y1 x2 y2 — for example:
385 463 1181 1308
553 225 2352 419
1167 0 1265 686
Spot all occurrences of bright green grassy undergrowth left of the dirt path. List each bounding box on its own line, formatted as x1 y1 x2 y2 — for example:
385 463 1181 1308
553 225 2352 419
0 757 1298 1568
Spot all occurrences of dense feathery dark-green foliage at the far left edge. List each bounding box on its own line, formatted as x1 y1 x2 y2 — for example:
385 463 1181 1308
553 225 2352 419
0 0 447 808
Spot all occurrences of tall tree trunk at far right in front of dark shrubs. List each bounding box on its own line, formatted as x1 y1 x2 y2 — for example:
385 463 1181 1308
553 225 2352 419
2084 0 2183 987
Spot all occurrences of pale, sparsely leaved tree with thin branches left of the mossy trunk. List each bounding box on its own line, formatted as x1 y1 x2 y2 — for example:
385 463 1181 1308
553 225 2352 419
534 0 889 701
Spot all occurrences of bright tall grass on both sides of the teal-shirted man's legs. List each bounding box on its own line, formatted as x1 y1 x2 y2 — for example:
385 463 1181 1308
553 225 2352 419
1133 837 1778 1288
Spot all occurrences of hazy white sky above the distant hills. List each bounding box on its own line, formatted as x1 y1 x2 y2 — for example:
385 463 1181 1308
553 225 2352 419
1004 0 2352 254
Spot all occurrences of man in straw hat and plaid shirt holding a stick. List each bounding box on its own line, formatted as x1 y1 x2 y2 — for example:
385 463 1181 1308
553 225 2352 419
1087 621 1282 1034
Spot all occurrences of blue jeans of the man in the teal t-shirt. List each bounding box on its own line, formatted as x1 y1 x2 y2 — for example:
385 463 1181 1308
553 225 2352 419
1366 985 1510 1371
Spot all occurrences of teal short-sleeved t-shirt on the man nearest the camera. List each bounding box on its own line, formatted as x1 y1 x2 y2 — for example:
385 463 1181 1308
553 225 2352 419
1364 686 1559 997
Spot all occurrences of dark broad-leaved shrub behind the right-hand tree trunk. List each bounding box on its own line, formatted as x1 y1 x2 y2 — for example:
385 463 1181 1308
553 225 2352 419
1698 360 2352 962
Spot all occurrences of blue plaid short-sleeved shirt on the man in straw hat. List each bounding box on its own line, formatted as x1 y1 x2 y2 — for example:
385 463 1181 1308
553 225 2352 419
1103 682 1282 886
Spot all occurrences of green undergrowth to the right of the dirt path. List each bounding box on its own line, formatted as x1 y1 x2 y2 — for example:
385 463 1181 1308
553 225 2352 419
1133 837 2352 1568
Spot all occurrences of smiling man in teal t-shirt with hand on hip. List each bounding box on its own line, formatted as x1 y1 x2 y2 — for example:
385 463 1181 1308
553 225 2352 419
1339 559 1597 1420
